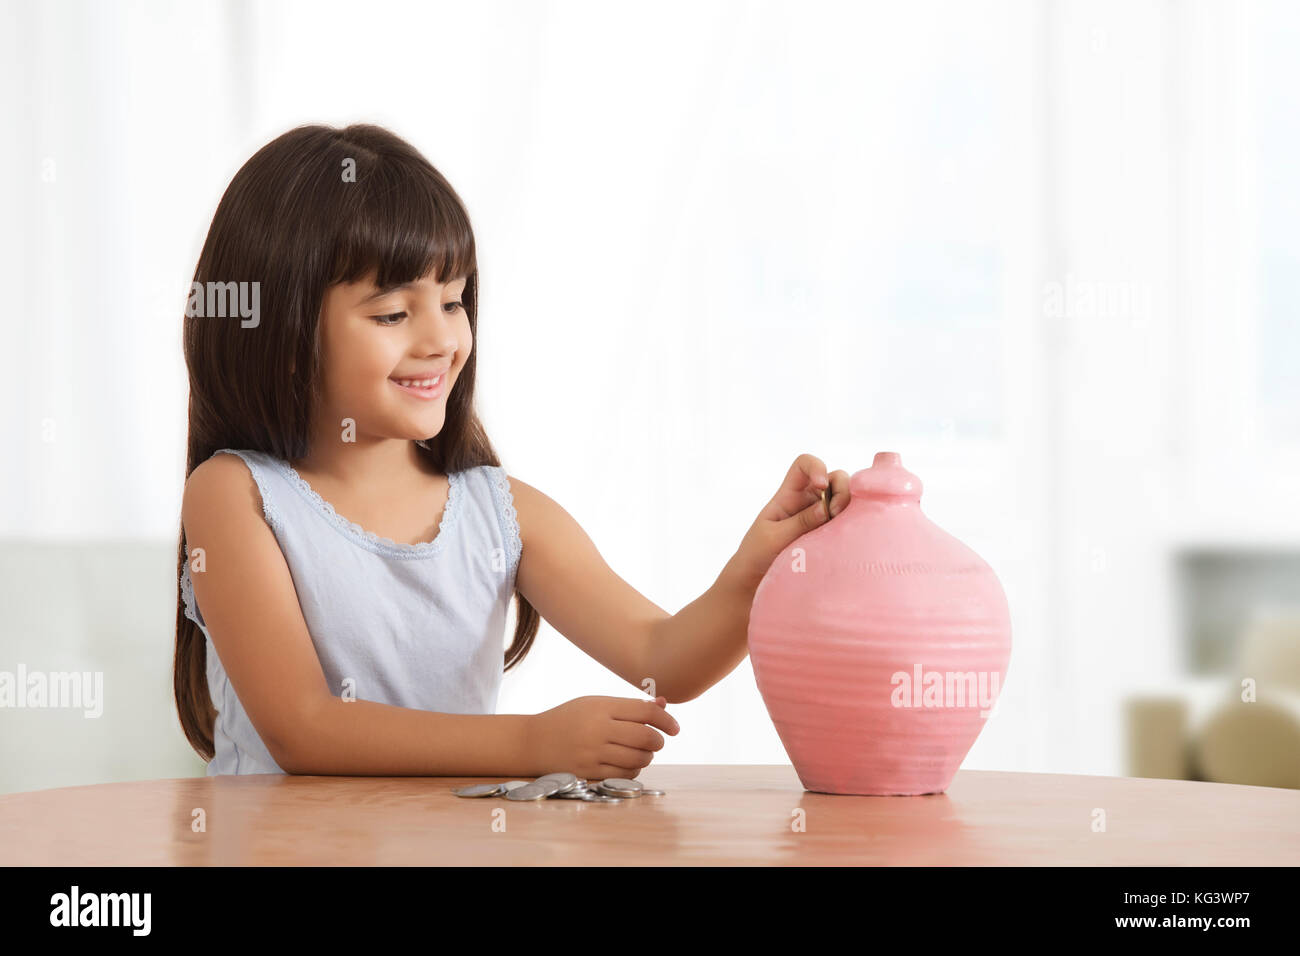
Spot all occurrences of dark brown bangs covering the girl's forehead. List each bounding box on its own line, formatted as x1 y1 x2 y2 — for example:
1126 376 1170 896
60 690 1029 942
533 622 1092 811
330 153 475 289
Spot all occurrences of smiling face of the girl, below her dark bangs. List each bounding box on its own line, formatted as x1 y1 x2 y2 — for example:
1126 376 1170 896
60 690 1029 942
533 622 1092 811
321 273 473 440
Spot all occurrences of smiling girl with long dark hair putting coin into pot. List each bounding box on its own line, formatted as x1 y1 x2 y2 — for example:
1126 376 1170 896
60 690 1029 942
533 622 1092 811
174 125 849 778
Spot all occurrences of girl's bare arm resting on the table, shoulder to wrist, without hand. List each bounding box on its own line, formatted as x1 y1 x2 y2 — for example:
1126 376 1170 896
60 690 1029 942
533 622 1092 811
182 454 533 778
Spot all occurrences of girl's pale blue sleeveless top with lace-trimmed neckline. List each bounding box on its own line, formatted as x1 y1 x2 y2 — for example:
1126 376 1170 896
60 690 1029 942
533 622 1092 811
181 449 521 777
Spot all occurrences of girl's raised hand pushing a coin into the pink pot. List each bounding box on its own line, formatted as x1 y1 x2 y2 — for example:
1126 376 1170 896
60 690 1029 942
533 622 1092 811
724 455 849 588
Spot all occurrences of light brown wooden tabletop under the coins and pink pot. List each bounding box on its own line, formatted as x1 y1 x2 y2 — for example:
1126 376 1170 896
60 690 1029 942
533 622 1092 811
0 763 1300 866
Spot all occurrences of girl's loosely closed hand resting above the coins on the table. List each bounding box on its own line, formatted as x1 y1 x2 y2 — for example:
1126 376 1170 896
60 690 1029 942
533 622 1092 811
529 697 681 779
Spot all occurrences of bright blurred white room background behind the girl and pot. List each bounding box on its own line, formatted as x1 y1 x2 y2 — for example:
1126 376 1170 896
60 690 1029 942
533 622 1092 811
0 0 1300 792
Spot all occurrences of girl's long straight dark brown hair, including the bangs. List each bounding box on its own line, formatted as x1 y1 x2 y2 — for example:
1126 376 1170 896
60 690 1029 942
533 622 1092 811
173 125 538 760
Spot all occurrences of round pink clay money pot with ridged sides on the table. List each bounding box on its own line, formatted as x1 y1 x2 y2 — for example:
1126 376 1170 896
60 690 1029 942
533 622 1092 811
749 451 1011 795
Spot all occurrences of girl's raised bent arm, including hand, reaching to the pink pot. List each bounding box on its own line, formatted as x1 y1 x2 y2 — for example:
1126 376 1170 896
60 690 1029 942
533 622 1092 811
507 455 849 704
